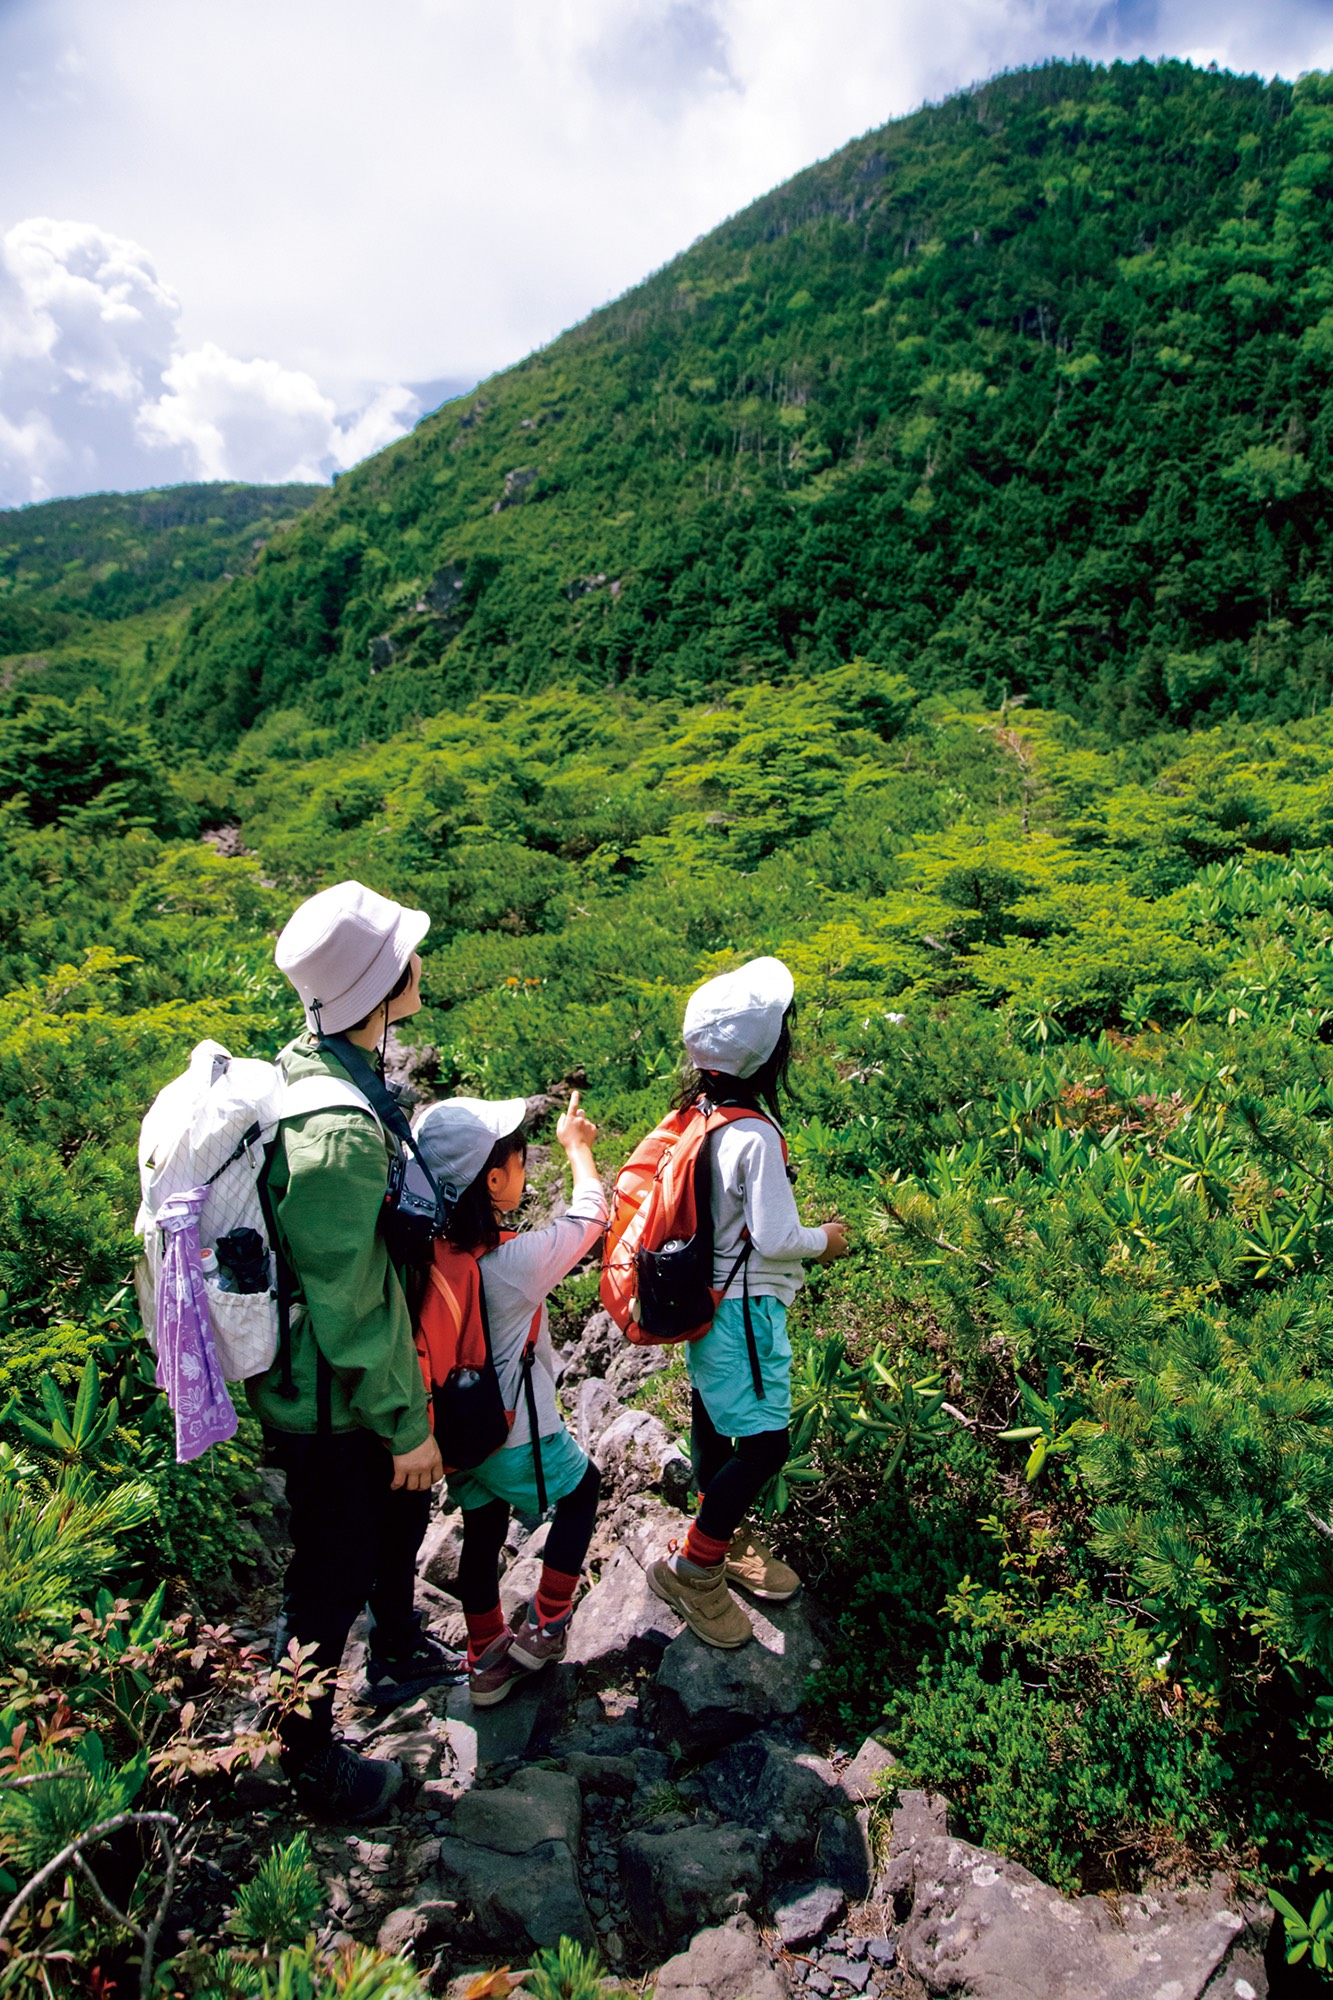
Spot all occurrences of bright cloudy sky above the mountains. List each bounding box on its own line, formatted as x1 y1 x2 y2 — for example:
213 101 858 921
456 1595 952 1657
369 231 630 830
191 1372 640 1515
0 0 1333 504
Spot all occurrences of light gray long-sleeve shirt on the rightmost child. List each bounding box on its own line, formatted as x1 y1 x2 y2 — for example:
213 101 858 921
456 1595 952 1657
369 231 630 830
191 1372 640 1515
713 1118 827 1306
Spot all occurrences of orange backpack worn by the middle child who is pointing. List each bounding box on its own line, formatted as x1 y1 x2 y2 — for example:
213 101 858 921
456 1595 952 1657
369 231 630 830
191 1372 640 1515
412 1230 546 1514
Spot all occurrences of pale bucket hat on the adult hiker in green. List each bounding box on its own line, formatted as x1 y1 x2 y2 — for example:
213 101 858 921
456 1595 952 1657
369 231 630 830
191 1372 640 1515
272 882 430 1034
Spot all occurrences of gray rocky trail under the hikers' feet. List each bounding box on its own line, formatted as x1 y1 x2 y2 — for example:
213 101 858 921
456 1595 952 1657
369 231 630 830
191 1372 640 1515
204 1314 1269 2000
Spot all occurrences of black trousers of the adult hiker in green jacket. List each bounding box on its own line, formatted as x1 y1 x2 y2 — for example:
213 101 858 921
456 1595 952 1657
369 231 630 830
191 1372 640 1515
264 1430 432 1762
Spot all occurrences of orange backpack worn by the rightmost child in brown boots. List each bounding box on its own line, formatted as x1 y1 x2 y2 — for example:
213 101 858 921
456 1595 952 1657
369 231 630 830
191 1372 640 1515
600 1098 787 1396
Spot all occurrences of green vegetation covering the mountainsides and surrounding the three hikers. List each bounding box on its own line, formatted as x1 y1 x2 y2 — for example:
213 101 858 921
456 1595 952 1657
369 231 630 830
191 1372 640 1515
0 47 1333 2000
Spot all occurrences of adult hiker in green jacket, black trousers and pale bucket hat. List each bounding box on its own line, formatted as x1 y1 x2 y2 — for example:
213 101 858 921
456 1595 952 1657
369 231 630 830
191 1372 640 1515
256 882 460 1820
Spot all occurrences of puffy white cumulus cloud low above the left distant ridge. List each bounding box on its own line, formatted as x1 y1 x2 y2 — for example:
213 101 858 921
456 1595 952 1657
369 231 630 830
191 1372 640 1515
0 216 418 506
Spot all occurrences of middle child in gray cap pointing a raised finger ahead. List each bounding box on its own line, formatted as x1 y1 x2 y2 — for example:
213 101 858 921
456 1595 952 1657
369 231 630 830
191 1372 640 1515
416 1092 606 1708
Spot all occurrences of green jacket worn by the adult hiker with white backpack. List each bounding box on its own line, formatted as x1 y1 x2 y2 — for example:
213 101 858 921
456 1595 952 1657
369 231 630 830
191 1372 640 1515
246 1034 430 1452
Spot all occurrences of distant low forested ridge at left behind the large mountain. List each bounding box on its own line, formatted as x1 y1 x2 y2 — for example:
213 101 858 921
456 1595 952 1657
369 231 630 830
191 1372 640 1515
0 484 322 658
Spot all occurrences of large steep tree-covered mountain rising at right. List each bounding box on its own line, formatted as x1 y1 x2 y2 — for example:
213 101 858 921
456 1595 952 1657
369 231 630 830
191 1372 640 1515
154 62 1333 742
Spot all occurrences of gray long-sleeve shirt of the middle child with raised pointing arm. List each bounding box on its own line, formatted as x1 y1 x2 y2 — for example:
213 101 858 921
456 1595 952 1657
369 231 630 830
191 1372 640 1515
478 1180 606 1450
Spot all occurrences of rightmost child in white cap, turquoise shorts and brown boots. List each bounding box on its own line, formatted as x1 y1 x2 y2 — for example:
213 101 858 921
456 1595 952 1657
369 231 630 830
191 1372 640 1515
648 958 847 1646
